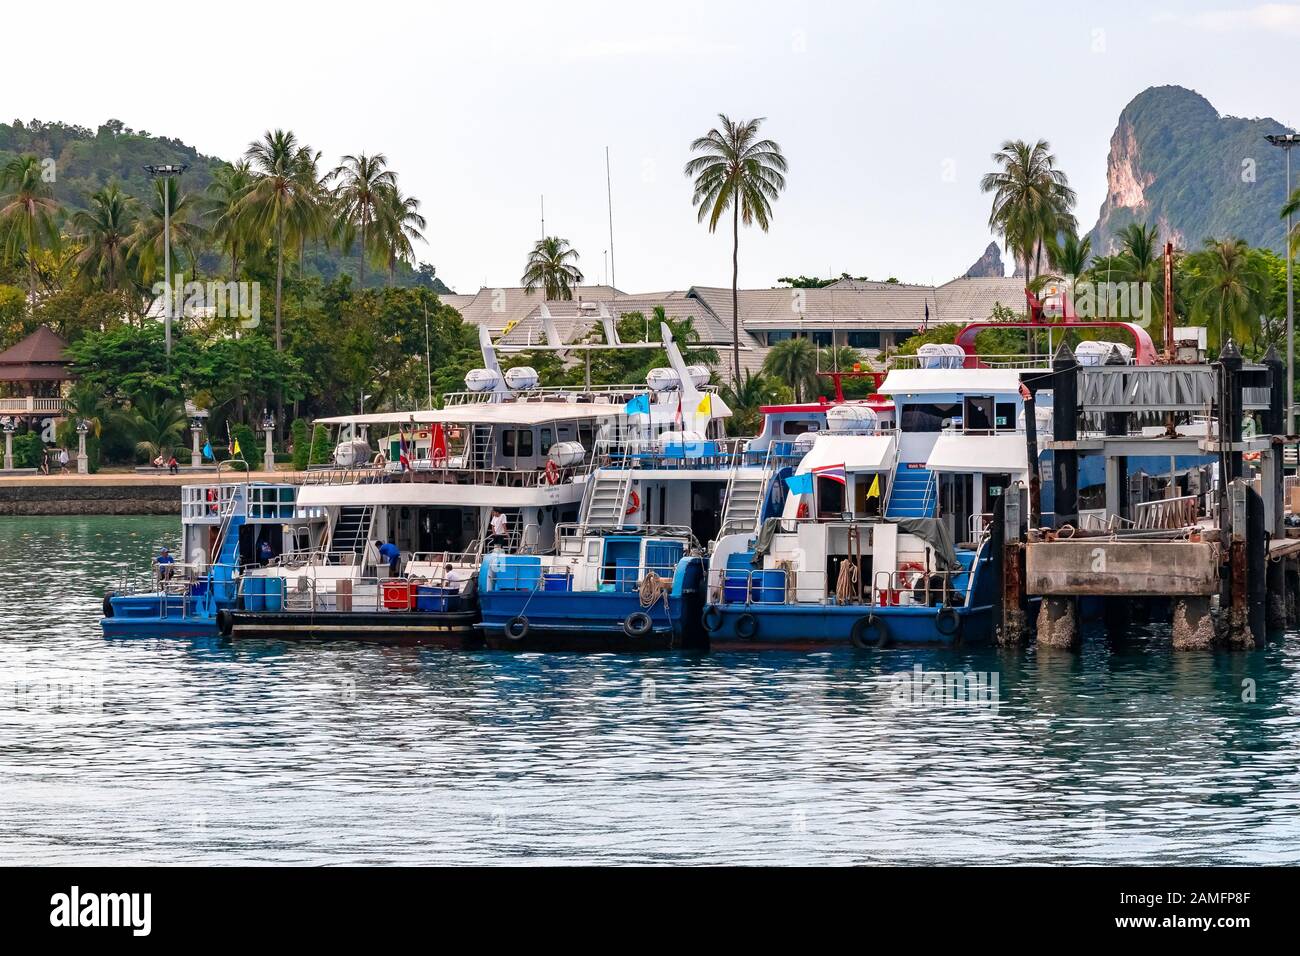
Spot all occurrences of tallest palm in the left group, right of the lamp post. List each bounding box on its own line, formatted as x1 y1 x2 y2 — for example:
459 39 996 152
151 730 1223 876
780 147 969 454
238 130 315 351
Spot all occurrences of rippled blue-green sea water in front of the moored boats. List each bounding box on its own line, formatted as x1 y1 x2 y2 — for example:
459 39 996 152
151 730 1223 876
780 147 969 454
0 518 1300 864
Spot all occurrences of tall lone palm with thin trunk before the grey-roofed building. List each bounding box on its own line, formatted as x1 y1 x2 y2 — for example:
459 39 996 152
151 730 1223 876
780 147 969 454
685 113 787 386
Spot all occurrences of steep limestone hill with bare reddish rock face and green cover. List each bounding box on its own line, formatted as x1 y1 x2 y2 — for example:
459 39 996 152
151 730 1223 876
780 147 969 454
1092 86 1300 252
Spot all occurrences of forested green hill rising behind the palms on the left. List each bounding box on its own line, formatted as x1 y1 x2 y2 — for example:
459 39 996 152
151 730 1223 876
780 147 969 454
0 120 451 293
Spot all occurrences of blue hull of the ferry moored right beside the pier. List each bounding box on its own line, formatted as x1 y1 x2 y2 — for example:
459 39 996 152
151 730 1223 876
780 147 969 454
706 604 993 650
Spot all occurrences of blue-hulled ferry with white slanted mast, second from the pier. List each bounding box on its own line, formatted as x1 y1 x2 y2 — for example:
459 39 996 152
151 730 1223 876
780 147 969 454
478 326 774 650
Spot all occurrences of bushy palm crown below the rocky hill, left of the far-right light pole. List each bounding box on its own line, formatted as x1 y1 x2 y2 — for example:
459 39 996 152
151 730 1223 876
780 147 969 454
1187 239 1270 346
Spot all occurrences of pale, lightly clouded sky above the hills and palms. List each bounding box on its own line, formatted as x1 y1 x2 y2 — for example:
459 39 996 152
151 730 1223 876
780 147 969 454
0 0 1300 293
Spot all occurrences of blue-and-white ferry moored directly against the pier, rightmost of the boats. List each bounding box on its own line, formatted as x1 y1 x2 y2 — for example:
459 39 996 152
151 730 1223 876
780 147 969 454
703 356 1047 649
